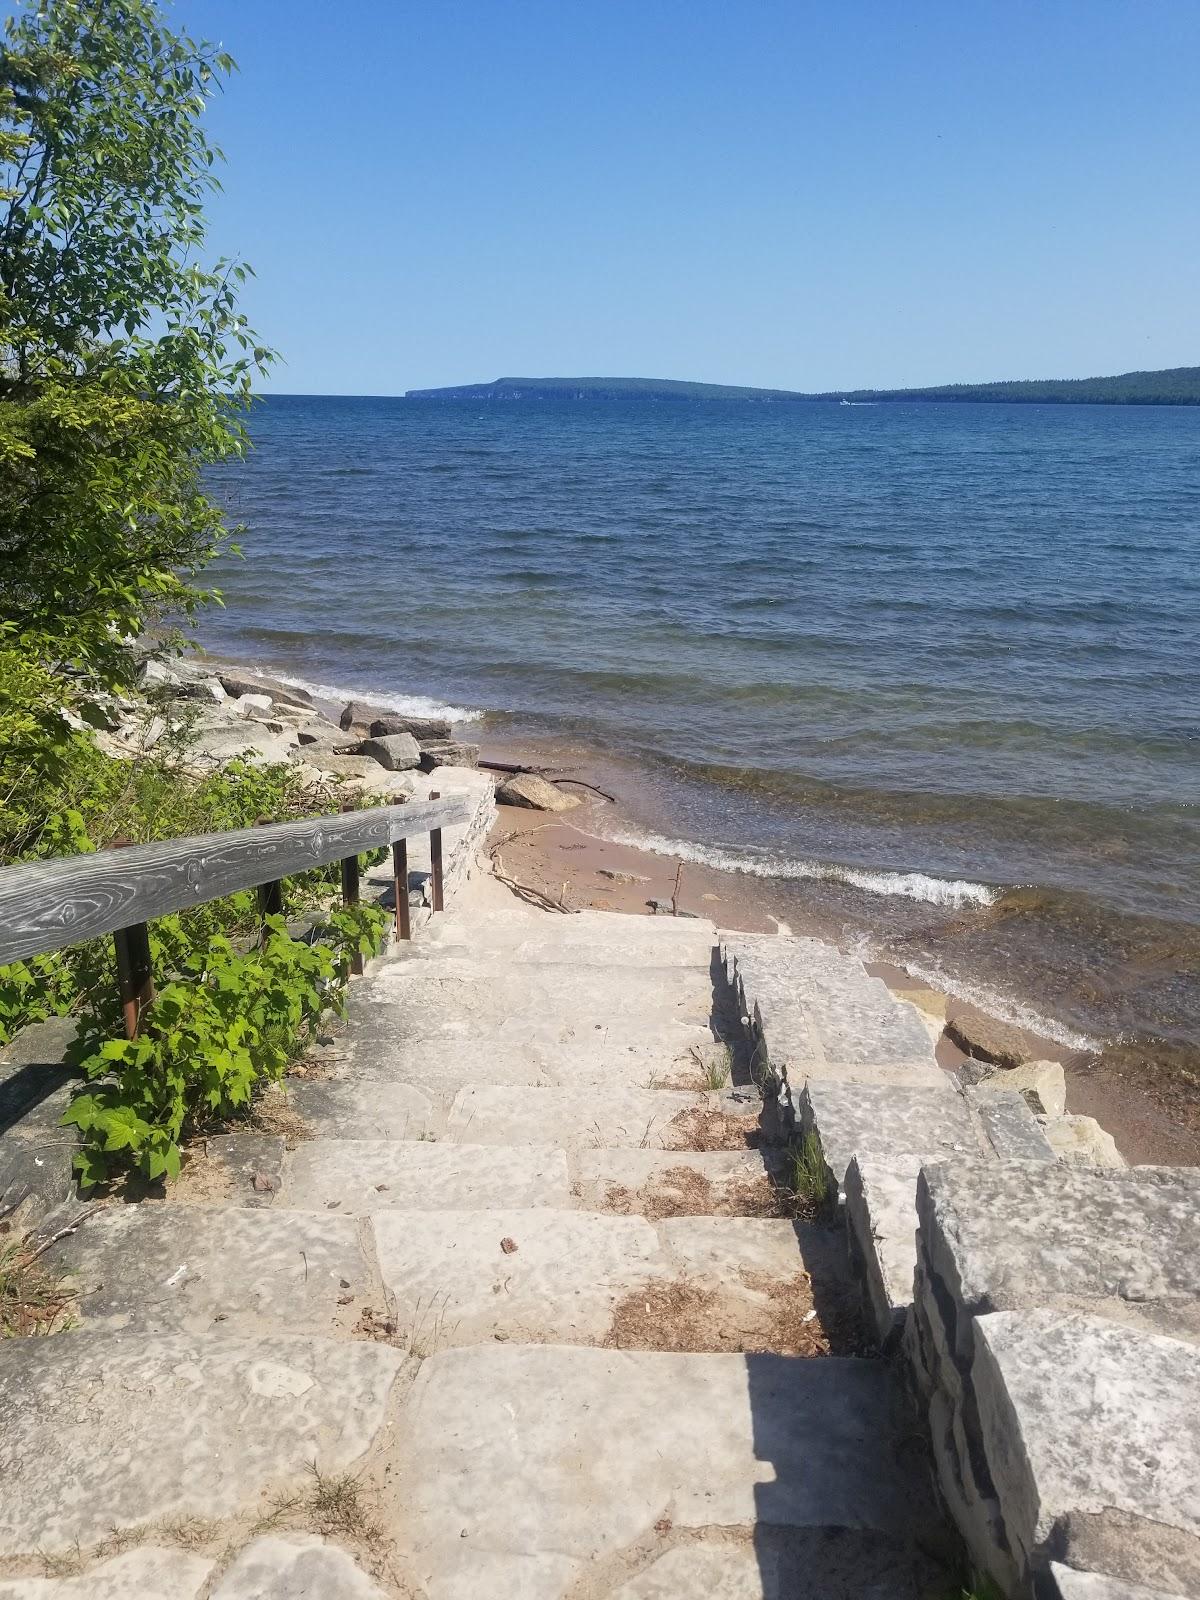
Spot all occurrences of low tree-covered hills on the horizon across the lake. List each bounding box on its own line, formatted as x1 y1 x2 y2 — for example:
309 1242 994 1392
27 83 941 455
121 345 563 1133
405 366 1200 405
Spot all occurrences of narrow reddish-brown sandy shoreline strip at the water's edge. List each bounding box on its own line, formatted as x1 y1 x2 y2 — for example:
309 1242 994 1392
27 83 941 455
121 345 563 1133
188 651 1200 1165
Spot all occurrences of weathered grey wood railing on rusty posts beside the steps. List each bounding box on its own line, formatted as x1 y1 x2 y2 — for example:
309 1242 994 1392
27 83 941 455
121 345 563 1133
0 795 470 1038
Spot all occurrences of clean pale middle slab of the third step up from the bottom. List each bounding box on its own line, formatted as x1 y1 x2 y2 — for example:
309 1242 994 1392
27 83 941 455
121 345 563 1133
280 1139 571 1216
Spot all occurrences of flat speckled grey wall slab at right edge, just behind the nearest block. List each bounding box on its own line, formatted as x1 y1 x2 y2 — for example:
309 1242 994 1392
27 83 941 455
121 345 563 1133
917 1162 1200 1357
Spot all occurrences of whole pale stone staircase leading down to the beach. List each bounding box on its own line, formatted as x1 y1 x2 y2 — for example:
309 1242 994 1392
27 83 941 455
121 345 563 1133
0 877 958 1600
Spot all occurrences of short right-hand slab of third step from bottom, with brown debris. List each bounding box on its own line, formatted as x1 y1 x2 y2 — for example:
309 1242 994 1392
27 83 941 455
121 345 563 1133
571 1149 786 1216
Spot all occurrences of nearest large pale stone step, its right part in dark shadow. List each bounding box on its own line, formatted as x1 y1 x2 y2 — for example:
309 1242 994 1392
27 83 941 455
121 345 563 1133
392 1344 950 1600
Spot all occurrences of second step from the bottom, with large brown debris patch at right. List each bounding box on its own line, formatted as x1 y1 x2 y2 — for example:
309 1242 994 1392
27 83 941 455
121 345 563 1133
371 1208 843 1355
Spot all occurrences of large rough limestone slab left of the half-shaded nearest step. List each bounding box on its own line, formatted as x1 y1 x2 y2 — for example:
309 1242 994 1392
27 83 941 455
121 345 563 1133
0 1331 405 1557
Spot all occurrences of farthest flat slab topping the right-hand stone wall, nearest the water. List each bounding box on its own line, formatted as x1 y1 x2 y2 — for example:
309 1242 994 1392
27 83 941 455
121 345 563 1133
722 934 941 1093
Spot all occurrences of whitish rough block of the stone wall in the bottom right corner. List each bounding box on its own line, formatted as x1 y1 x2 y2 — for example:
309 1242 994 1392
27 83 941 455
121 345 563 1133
971 1310 1200 1594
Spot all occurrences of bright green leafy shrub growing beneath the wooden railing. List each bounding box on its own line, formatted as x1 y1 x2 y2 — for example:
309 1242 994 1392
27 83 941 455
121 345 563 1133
62 906 387 1187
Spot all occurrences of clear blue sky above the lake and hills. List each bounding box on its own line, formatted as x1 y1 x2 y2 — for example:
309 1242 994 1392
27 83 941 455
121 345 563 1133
174 0 1200 394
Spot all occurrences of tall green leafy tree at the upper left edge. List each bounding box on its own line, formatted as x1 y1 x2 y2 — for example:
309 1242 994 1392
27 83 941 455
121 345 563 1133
0 0 272 825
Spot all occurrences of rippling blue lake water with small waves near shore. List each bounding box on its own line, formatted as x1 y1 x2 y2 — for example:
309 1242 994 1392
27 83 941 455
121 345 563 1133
202 397 1200 1045
